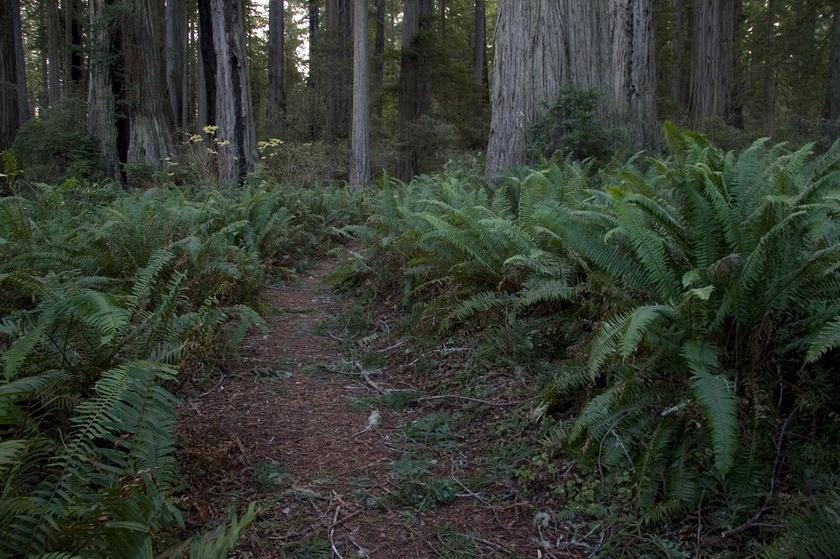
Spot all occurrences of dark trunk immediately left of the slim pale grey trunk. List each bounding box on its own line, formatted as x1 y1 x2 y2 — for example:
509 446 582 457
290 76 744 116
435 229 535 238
324 0 353 143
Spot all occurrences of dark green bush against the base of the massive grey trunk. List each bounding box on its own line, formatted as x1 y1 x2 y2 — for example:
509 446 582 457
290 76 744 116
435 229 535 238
528 86 621 161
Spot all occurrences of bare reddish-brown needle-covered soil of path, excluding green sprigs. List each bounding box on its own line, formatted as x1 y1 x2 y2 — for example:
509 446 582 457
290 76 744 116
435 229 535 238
179 260 573 558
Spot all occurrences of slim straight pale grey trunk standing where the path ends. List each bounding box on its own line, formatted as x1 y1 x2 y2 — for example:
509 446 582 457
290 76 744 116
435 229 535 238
350 0 370 188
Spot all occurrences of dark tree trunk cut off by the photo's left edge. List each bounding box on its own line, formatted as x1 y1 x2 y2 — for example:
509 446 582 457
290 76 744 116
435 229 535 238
0 0 29 151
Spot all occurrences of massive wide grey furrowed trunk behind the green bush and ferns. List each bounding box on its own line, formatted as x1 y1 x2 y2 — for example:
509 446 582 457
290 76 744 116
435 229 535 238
487 0 658 177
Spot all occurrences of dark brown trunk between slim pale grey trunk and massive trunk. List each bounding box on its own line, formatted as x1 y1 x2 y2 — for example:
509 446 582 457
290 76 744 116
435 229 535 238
397 0 434 181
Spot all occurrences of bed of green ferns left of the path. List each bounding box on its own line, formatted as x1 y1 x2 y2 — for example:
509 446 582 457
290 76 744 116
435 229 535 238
0 180 360 558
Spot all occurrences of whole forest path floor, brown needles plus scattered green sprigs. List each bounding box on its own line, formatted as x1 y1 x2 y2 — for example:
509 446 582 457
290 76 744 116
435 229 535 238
179 253 581 559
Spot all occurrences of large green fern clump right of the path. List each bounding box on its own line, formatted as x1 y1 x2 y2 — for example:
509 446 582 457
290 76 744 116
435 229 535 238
347 124 840 556
